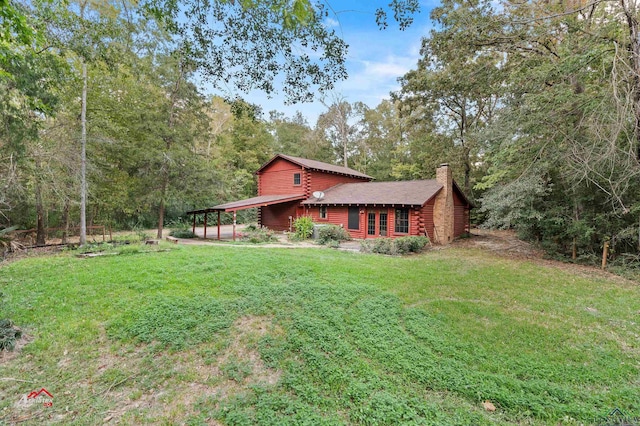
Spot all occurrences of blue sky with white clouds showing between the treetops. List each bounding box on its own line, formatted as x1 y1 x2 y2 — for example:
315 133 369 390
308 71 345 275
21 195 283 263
208 0 435 126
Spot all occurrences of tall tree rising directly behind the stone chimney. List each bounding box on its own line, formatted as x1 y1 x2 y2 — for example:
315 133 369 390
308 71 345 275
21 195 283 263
398 24 503 195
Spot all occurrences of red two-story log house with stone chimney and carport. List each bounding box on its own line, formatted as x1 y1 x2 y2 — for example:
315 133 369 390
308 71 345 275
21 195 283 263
187 154 472 244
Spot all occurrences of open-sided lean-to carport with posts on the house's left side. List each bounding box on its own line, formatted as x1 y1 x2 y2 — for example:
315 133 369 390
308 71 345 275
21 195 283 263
187 194 306 241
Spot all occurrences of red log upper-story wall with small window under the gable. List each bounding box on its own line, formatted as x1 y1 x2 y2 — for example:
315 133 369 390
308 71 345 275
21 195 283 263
258 158 369 197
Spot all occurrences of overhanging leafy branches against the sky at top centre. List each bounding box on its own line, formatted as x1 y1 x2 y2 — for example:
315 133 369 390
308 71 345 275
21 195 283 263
141 0 420 103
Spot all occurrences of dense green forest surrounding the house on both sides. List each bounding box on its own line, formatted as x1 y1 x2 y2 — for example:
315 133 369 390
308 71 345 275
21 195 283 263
0 0 640 265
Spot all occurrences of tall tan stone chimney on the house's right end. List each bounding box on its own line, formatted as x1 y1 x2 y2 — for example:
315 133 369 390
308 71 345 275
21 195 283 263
433 163 454 244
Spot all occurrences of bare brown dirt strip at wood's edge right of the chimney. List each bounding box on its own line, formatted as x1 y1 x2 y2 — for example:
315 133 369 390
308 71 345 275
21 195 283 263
450 228 638 285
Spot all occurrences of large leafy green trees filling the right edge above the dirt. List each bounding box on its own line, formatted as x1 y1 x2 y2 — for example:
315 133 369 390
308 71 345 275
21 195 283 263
424 1 640 256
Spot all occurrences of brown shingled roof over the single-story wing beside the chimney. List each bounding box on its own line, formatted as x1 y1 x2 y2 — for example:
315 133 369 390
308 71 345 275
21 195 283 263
303 179 442 206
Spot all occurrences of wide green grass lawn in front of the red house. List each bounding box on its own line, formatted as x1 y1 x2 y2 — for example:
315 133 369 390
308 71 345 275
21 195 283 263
0 246 640 425
